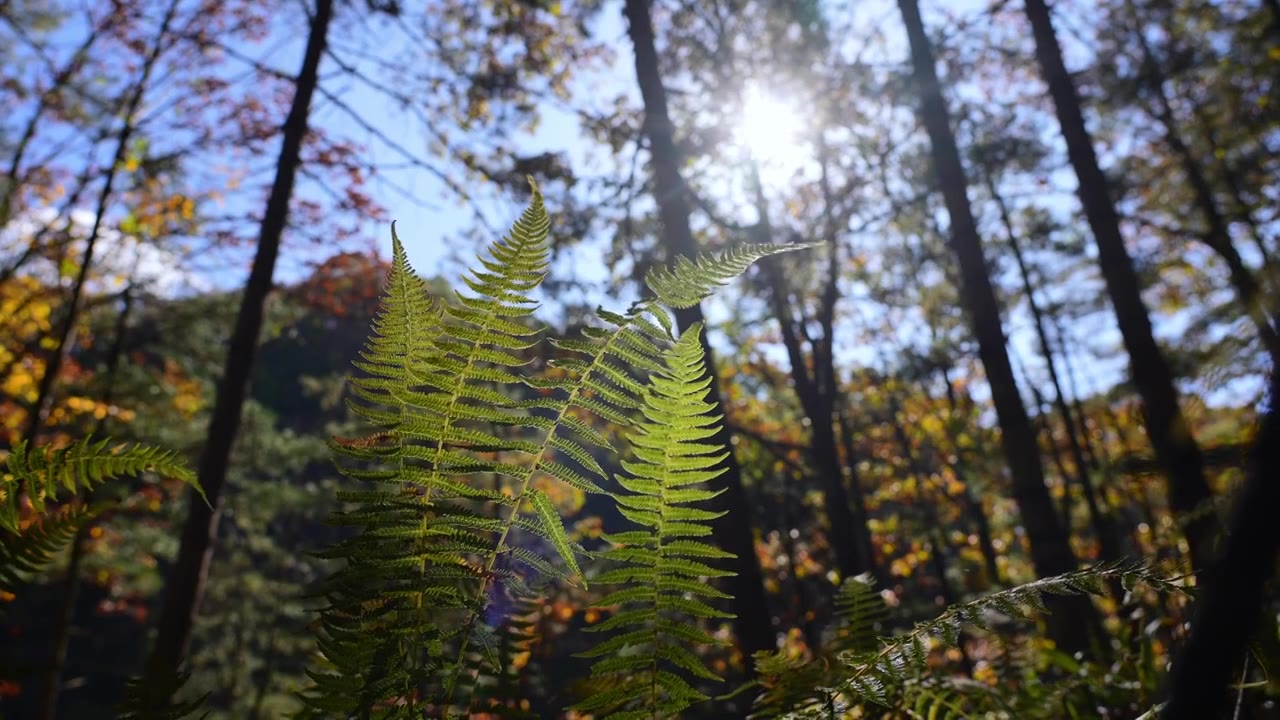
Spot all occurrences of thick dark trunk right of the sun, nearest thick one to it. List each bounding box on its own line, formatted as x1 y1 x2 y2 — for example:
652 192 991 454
897 0 1098 652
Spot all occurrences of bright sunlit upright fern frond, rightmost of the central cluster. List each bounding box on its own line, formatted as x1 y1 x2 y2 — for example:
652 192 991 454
575 327 732 719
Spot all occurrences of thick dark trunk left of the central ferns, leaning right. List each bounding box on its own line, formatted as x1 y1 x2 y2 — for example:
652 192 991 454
147 0 334 675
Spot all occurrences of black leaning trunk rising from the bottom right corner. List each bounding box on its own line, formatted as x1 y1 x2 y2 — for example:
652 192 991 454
1160 369 1280 720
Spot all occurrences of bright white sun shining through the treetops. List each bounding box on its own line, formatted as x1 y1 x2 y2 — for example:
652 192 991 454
735 86 806 178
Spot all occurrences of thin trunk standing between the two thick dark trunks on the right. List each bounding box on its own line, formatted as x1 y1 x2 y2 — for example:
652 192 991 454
982 168 1123 560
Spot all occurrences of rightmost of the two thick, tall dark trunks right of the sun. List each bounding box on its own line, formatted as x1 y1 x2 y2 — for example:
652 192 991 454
1025 0 1217 568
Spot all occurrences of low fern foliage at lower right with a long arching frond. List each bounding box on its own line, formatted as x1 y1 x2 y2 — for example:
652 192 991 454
755 560 1189 720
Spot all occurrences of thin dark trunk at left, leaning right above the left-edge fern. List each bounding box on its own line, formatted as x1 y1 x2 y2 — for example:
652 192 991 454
22 0 178 445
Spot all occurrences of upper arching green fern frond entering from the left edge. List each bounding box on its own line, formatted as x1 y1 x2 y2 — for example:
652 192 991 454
0 437 204 533
